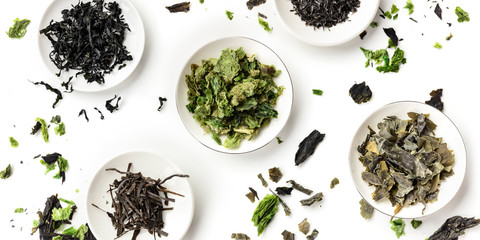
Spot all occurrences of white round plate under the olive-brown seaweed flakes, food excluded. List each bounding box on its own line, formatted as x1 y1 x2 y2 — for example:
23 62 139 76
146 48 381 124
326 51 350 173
349 101 467 218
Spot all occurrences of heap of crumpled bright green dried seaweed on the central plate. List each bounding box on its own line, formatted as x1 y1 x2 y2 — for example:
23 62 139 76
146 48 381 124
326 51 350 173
185 48 283 149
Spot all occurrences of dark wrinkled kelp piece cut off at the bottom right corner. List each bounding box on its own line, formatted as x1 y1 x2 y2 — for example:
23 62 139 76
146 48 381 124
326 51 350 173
428 216 480 240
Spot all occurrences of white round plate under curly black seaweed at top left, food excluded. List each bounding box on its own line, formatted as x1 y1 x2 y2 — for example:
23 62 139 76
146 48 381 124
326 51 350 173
38 0 145 92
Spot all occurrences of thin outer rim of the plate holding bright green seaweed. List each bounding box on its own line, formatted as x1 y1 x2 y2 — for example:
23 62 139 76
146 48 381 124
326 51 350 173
175 35 295 154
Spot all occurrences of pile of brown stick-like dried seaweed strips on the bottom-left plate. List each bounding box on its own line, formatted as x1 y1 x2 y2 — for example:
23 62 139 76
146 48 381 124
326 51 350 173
99 163 189 240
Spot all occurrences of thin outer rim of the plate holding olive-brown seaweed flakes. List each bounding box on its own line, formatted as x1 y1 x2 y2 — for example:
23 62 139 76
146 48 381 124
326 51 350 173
348 100 468 219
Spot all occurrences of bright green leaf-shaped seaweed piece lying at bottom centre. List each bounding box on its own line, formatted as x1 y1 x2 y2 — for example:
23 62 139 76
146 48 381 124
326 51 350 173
252 194 279 236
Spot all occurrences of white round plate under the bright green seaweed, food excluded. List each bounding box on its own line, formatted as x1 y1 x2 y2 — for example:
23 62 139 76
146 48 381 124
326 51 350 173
175 37 293 153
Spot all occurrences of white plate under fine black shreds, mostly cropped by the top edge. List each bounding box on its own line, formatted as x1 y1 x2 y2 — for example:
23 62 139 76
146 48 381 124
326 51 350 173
274 0 380 46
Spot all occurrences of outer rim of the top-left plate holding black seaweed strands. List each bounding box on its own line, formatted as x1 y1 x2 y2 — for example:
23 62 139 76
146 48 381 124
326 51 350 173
36 0 146 93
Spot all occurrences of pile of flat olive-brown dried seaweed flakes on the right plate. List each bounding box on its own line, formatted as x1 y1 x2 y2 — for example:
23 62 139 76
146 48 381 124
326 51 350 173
357 112 455 210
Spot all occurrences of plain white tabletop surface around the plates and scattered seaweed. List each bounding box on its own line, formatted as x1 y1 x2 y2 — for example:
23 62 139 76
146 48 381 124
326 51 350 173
0 0 480 240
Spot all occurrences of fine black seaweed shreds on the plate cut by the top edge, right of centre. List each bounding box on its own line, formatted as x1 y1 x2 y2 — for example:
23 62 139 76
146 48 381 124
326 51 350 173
291 0 360 29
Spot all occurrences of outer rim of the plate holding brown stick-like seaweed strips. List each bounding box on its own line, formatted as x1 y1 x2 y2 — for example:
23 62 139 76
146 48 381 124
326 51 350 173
83 149 195 239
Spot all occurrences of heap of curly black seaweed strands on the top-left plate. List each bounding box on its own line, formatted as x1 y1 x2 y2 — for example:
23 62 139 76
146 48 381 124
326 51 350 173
40 0 132 84
